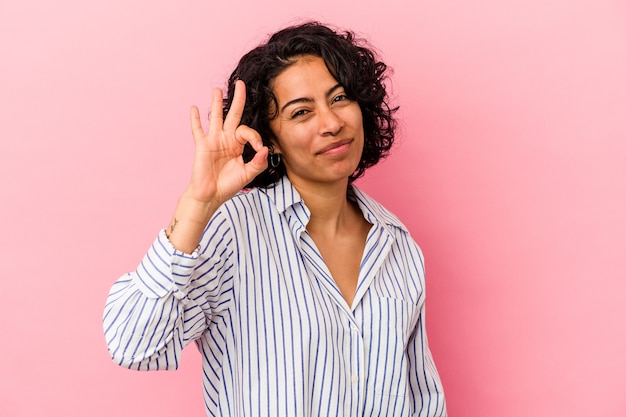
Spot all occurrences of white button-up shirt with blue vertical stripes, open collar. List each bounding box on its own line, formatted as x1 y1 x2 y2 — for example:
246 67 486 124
104 177 446 417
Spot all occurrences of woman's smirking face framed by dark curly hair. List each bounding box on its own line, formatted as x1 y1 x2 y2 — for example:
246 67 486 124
270 56 364 186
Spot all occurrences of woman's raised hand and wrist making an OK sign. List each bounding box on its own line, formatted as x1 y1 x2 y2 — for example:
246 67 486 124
166 81 269 253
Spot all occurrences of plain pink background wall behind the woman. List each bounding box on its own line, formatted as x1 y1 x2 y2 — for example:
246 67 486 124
0 0 626 417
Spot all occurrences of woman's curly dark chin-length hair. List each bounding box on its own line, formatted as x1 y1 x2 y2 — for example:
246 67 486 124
224 22 398 188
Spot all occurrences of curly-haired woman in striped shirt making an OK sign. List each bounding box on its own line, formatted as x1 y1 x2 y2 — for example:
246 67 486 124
104 23 446 416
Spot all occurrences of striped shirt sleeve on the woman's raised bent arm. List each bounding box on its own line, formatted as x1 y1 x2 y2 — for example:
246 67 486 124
103 223 232 370
